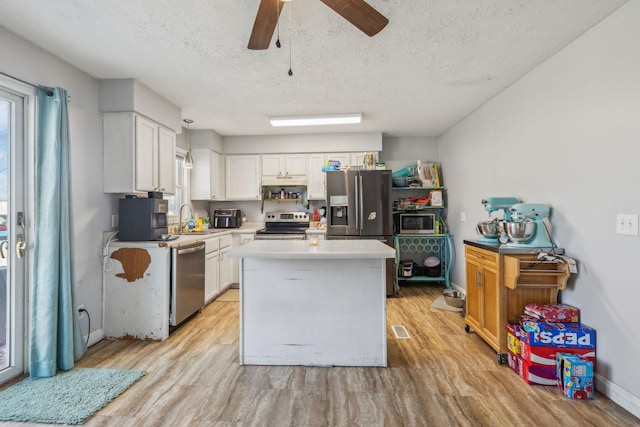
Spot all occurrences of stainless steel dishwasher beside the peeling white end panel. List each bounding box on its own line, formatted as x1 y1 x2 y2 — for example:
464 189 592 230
169 241 205 326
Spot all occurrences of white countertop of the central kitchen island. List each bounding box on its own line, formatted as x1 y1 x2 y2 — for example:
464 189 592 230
227 240 396 259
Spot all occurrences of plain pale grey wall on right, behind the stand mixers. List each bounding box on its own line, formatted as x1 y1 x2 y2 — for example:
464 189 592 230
440 2 640 416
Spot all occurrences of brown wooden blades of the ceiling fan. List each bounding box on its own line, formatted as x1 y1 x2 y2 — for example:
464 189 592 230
248 0 389 50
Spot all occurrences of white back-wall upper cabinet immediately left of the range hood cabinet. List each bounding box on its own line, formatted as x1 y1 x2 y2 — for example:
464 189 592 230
225 154 261 200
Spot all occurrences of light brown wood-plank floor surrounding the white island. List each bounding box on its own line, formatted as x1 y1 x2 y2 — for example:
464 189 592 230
0 285 640 427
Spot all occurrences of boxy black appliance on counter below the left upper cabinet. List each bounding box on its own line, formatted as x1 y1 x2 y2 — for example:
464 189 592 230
118 198 169 241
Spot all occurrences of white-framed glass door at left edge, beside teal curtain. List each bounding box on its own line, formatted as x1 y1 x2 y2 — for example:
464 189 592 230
0 79 35 383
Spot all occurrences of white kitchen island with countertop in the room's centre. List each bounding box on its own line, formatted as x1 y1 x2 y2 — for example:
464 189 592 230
228 240 395 366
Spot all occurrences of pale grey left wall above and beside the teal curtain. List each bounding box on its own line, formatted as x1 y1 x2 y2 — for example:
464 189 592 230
0 27 111 342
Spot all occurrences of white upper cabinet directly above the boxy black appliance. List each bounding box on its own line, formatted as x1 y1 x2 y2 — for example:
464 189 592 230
102 112 176 194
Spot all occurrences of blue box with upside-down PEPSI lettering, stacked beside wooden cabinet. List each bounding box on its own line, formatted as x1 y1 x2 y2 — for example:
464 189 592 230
520 319 596 350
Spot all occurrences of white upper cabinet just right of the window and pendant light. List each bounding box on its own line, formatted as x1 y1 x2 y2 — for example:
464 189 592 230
191 149 225 201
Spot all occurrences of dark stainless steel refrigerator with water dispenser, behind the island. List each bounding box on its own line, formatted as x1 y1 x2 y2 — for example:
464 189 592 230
326 170 397 296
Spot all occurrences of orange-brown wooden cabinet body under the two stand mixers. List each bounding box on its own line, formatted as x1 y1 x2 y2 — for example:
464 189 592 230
465 244 570 363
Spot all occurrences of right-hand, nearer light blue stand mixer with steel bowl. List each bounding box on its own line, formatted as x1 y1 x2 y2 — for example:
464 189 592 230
503 203 554 248
